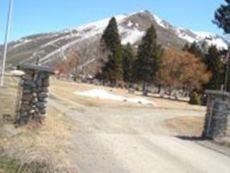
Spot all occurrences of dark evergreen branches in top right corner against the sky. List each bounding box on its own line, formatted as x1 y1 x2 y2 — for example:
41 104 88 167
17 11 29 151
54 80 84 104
213 0 230 34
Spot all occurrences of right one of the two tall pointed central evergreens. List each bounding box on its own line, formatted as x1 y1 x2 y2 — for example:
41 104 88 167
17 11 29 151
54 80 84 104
135 25 163 95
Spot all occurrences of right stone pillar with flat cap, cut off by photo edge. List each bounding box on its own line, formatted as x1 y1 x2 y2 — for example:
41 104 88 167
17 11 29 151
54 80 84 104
203 91 230 139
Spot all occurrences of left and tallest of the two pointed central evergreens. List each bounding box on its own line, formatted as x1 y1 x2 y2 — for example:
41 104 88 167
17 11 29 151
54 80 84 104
100 17 122 84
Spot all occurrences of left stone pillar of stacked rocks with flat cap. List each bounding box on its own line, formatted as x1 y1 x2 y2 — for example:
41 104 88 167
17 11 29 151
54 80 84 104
17 65 52 124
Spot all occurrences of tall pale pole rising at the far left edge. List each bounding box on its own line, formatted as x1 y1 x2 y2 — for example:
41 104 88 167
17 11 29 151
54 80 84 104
0 0 14 86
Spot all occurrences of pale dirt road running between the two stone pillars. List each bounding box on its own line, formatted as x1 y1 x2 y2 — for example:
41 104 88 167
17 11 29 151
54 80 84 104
50 81 230 173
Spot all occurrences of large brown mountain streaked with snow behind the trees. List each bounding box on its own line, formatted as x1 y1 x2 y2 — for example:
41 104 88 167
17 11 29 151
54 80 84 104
0 11 227 69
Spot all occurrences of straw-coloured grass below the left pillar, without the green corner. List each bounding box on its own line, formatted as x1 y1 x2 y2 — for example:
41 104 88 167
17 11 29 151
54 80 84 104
0 107 76 173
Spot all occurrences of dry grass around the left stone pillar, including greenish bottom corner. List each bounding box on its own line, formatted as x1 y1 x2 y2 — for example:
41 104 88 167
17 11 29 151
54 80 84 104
0 78 76 173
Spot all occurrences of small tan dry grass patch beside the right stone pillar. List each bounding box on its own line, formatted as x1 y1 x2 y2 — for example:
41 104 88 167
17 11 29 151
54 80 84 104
165 116 204 136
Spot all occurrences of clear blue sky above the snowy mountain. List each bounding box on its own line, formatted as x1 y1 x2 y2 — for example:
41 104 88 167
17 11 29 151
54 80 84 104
0 0 227 42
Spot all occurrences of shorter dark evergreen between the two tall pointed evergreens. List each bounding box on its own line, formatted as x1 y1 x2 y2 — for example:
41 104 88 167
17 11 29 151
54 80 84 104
122 44 134 83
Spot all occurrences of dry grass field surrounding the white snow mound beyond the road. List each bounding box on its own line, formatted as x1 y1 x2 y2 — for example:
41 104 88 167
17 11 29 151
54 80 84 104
51 79 206 111
